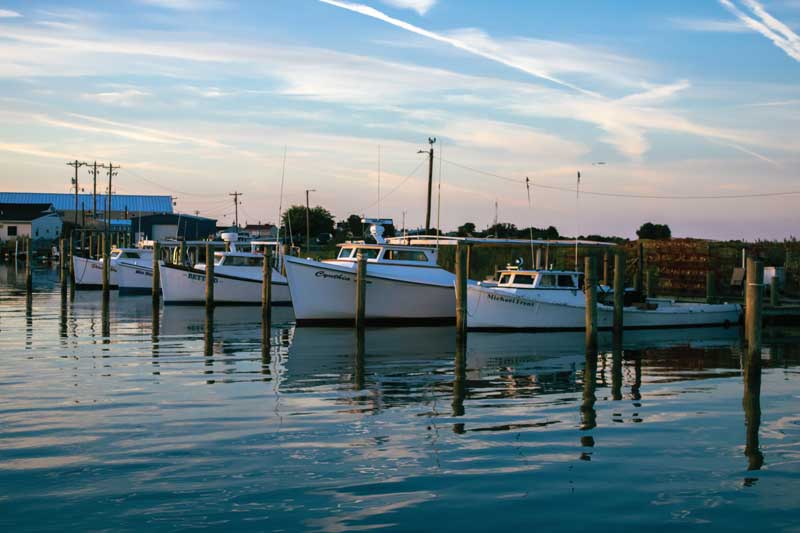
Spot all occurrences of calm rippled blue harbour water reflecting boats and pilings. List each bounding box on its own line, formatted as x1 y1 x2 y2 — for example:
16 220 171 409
0 267 800 531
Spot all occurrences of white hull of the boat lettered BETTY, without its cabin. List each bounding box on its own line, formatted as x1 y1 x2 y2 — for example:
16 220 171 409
160 264 291 305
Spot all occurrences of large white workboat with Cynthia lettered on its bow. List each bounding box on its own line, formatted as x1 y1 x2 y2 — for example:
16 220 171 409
285 219 455 325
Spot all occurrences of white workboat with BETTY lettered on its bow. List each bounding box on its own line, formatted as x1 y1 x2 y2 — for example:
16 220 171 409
160 233 291 305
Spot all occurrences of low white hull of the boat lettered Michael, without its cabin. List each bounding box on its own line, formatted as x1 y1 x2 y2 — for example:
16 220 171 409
467 284 741 331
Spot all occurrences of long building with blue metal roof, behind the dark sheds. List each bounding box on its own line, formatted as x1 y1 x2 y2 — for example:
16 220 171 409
0 192 173 226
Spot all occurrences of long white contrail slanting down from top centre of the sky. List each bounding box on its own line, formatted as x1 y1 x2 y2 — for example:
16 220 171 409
319 0 605 98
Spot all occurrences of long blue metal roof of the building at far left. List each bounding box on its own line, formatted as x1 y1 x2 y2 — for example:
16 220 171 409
0 192 172 215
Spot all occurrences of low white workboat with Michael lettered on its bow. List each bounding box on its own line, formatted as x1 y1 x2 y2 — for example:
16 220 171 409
467 267 742 331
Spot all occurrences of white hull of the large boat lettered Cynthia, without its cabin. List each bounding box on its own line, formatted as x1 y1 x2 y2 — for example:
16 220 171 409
286 257 455 325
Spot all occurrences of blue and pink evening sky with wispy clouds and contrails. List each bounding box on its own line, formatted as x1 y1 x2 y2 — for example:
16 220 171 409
0 0 800 239
